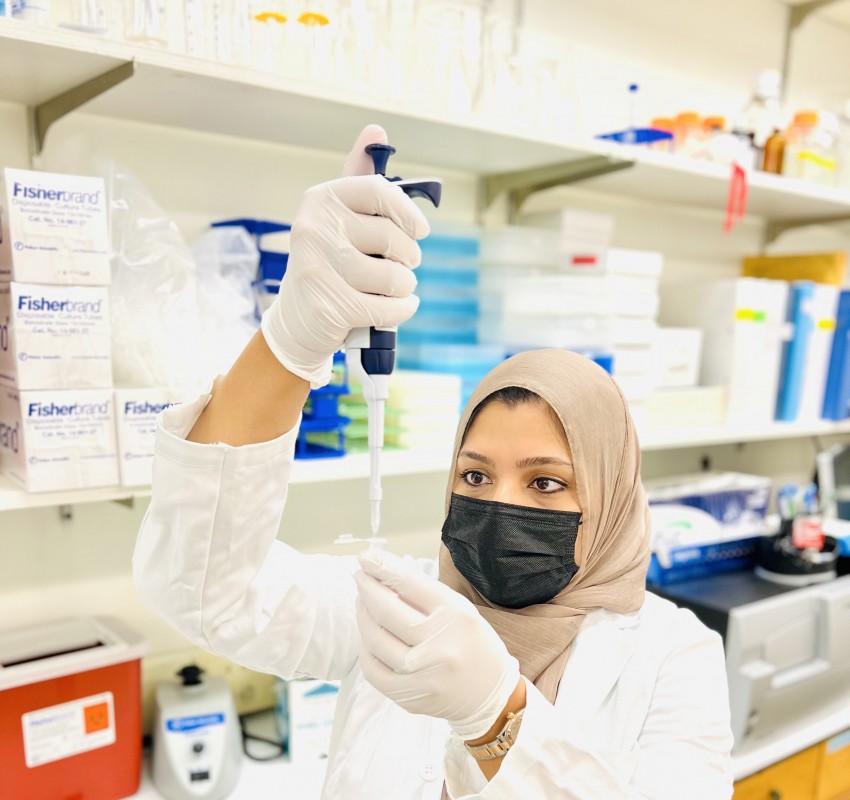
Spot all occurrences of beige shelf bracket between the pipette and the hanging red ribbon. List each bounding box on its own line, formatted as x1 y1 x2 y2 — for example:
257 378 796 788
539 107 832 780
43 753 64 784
478 156 634 223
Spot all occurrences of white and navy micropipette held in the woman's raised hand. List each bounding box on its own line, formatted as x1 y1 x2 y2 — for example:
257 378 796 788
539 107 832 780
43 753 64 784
345 144 442 539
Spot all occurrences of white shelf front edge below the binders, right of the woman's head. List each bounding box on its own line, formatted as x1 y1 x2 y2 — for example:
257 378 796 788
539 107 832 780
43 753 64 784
638 420 850 451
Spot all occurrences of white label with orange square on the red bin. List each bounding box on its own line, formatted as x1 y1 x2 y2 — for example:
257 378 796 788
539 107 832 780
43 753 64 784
21 692 115 768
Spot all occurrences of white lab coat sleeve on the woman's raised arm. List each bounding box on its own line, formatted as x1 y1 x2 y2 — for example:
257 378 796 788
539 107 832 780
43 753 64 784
133 388 360 679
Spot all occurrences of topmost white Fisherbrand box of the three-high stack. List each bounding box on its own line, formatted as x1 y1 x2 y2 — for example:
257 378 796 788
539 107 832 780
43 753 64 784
0 167 110 286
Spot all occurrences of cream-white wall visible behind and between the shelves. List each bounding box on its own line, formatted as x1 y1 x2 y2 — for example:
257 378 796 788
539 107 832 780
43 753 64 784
0 0 850 688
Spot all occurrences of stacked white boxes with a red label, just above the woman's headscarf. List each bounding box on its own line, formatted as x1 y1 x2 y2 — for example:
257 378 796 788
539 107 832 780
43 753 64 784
478 227 663 418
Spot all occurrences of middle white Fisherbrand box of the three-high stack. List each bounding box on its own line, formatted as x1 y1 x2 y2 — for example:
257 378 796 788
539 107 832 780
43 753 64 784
0 283 112 390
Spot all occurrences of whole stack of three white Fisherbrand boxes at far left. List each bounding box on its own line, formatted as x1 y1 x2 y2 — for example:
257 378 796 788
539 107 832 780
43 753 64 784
0 169 118 492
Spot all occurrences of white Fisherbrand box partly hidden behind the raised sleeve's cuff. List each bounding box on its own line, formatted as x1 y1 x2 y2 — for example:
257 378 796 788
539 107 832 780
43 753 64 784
115 389 187 486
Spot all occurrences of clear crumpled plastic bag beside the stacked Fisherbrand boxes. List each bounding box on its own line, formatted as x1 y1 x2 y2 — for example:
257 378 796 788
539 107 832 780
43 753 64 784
102 162 259 392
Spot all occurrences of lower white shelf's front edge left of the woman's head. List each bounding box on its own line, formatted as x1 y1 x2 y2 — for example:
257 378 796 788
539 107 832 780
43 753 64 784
0 443 452 511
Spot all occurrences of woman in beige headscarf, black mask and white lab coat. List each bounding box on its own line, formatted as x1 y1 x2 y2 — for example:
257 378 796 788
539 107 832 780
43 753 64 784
134 126 731 800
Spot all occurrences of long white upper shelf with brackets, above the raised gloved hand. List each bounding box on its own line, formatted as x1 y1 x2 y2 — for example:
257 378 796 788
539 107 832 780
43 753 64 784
0 19 850 224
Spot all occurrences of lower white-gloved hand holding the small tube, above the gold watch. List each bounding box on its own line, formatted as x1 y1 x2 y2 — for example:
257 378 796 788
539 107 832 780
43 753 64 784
354 550 519 739
